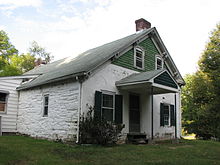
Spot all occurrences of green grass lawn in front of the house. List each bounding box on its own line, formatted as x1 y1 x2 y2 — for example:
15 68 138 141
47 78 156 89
0 136 220 165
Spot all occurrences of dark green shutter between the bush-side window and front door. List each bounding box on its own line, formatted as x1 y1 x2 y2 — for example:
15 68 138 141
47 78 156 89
115 95 123 124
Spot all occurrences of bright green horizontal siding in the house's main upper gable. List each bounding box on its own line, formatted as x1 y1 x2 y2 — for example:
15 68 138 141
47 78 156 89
112 38 159 72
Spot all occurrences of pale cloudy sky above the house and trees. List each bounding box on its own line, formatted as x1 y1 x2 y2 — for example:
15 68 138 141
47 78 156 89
0 0 220 76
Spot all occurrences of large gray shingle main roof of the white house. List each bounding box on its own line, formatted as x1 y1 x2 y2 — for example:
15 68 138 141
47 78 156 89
18 28 154 90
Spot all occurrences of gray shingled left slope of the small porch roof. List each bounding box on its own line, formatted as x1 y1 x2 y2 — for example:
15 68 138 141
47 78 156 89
116 69 165 86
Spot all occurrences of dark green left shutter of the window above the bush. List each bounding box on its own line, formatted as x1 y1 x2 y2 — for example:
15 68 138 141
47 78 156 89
94 91 102 119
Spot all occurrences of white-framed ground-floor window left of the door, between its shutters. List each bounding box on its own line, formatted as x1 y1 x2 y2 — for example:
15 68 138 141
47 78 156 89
102 93 114 121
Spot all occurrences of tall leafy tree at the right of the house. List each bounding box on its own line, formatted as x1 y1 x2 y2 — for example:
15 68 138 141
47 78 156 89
182 24 220 139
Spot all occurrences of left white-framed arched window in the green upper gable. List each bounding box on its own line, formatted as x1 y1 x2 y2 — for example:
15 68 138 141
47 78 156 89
134 47 144 70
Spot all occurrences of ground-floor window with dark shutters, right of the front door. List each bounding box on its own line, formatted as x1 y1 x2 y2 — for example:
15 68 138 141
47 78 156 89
160 103 175 126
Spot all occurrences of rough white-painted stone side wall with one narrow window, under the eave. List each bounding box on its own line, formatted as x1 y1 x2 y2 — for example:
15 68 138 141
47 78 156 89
18 80 79 140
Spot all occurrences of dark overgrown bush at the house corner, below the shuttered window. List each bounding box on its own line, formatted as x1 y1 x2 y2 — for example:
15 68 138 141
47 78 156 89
79 107 123 145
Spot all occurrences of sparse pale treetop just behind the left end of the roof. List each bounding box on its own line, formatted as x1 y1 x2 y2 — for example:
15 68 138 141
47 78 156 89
29 41 53 63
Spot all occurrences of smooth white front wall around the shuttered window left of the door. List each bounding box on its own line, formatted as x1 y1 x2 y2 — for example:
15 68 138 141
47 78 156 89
81 63 137 135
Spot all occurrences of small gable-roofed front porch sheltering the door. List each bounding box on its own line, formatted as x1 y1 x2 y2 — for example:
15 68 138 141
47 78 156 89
116 69 179 140
